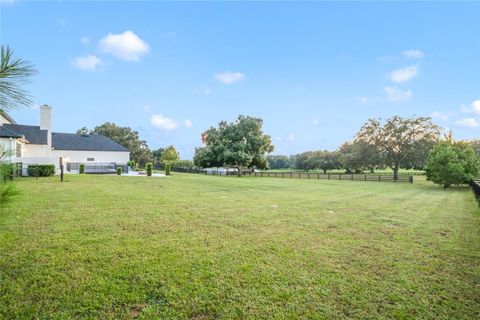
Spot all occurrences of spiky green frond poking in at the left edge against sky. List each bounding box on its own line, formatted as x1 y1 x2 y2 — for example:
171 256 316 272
0 45 36 110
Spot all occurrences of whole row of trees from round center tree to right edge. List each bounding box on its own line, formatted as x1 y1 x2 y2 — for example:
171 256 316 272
194 115 480 186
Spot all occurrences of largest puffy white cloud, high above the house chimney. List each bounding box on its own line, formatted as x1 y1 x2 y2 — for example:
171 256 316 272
98 30 150 61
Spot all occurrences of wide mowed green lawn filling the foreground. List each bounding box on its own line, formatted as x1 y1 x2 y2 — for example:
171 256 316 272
0 174 480 319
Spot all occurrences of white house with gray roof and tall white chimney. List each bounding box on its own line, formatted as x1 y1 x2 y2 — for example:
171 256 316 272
0 105 130 171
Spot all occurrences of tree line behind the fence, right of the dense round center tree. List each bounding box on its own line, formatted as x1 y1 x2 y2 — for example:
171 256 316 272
267 116 480 177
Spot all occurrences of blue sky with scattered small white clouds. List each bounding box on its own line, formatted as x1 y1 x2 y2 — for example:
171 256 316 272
0 0 480 158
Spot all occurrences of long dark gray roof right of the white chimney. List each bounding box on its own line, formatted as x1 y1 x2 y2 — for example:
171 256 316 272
52 132 128 151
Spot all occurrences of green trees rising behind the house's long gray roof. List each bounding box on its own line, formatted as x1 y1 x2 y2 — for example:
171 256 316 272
77 122 153 167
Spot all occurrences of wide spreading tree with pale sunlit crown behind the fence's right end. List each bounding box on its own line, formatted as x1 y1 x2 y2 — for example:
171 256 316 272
355 116 440 179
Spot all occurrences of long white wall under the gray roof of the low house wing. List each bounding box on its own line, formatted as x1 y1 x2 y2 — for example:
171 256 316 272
51 150 130 164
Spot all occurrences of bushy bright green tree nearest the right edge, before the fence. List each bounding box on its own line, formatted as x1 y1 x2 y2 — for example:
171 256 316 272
426 139 480 188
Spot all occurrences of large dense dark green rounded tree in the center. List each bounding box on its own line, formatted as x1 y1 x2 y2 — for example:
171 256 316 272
194 115 273 169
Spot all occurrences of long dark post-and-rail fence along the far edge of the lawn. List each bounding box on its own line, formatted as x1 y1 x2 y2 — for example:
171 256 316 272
173 168 413 183
